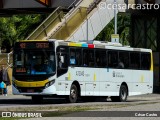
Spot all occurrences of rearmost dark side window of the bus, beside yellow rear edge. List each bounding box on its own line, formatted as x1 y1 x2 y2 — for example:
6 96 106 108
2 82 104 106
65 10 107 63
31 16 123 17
141 53 151 70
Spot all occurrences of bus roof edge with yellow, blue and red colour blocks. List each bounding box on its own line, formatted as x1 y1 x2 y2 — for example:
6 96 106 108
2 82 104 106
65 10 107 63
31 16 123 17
19 39 152 52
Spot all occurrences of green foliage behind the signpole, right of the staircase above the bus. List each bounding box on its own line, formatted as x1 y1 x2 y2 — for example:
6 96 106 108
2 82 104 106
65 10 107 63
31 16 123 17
95 14 130 45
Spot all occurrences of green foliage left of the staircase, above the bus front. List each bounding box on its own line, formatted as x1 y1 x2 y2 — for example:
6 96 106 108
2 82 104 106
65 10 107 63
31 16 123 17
0 14 44 51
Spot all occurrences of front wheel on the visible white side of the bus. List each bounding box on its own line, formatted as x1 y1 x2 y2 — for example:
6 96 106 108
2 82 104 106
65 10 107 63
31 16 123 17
69 84 78 103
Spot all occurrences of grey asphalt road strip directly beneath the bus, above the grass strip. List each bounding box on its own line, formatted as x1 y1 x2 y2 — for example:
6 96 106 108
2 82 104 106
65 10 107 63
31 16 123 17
0 94 160 110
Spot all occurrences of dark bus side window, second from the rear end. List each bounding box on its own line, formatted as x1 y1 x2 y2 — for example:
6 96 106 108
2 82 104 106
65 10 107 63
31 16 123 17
129 52 140 69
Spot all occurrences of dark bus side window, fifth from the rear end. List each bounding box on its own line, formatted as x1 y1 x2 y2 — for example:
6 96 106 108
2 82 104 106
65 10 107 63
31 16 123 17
95 49 107 68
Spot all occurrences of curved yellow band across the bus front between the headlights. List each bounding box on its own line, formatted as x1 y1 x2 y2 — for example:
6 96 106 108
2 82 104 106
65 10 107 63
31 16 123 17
14 80 49 87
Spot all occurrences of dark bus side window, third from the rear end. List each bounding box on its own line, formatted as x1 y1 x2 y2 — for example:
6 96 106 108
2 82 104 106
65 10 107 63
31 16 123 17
118 51 129 69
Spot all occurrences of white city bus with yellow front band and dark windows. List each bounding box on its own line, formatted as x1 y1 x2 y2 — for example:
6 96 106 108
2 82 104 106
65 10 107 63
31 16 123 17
13 39 153 103
